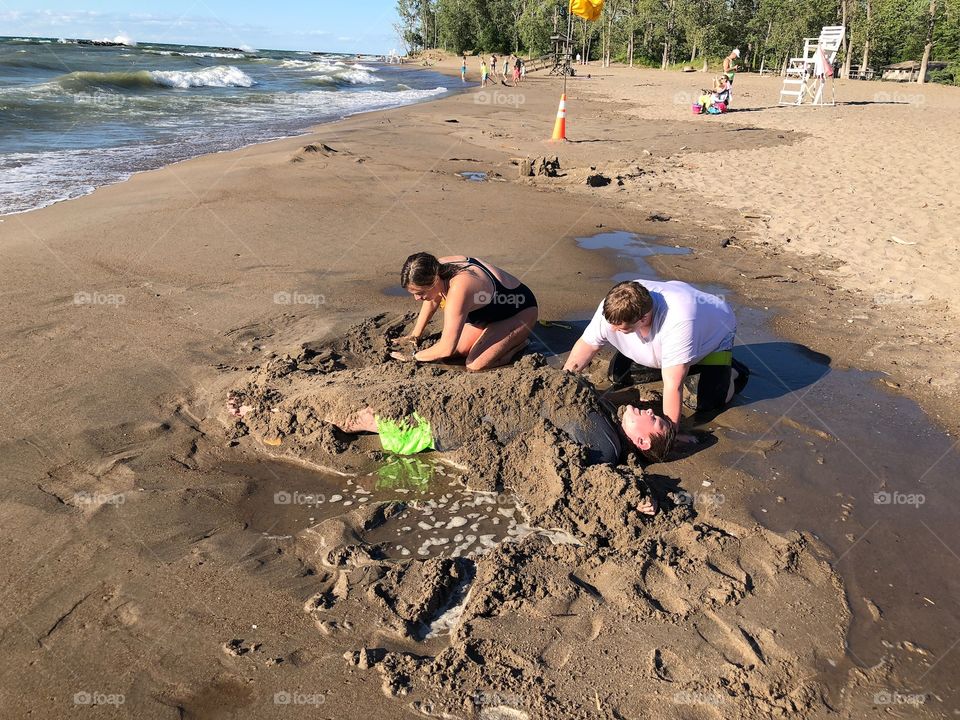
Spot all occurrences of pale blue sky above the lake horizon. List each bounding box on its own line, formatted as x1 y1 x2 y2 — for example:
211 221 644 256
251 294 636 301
0 0 402 54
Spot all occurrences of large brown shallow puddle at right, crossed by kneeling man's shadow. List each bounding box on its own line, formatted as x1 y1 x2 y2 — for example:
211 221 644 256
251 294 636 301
728 308 960 687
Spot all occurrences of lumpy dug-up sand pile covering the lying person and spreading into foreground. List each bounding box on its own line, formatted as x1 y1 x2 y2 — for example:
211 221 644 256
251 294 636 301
221 316 848 718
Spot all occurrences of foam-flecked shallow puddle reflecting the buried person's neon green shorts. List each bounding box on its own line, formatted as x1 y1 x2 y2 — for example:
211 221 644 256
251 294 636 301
220 457 575 560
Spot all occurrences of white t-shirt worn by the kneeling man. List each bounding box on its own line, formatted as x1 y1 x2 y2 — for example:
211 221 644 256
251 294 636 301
580 278 737 368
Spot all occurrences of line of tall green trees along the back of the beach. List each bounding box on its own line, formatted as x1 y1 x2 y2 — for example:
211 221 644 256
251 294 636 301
396 0 960 85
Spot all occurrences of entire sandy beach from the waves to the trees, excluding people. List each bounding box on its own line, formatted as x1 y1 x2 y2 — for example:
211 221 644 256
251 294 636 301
0 53 960 719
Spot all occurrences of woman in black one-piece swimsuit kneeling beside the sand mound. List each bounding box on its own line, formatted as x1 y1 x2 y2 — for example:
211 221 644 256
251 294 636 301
391 252 538 370
